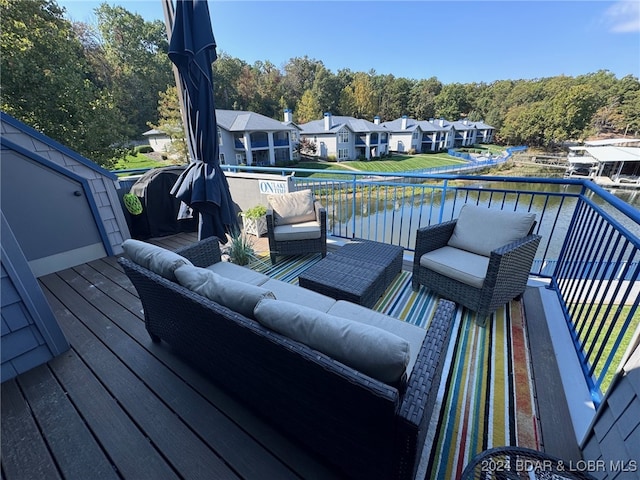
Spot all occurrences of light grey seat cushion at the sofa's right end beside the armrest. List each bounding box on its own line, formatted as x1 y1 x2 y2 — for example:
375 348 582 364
328 299 427 377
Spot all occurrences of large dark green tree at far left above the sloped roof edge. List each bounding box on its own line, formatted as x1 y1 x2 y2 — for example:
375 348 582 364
0 0 124 168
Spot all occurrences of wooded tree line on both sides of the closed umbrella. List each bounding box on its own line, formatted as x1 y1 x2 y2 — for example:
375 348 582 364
0 0 640 168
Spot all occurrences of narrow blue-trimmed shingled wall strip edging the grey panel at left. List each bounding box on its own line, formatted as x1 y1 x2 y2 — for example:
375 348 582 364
0 113 131 254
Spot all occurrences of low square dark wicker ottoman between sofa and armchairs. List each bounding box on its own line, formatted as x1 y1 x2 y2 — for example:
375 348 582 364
298 240 404 308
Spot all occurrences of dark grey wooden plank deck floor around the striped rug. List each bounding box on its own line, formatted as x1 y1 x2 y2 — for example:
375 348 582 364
0 234 579 480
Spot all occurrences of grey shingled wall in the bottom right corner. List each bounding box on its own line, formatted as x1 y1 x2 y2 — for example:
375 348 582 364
582 346 640 480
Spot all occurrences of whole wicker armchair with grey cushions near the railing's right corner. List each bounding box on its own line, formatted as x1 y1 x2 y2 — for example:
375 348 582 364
412 205 541 325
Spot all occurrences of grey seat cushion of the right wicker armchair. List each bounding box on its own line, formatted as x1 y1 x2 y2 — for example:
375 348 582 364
420 246 489 288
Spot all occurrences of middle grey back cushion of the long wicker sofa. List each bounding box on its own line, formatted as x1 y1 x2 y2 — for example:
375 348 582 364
175 265 276 318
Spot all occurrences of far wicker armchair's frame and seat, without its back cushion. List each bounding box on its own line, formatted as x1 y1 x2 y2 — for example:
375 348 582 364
267 193 327 264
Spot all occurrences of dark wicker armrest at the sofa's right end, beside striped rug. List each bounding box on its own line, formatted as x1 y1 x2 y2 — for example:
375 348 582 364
396 299 456 478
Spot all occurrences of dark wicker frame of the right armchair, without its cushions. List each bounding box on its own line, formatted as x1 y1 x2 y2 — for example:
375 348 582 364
412 207 541 325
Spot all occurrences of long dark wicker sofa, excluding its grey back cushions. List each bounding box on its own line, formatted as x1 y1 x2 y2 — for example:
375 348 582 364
119 238 455 479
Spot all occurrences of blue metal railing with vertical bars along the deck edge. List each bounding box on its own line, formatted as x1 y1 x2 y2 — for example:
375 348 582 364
115 160 640 405
